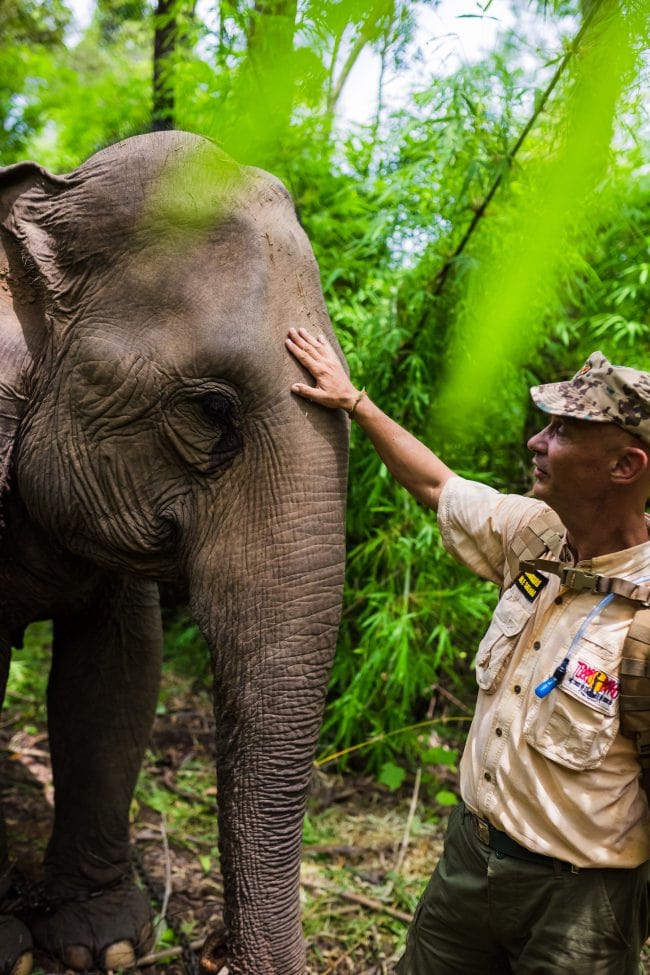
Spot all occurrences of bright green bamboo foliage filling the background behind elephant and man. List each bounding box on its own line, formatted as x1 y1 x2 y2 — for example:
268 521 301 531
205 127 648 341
0 0 650 780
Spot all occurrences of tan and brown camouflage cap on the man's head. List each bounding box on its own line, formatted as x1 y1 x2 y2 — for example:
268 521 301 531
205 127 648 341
530 352 650 444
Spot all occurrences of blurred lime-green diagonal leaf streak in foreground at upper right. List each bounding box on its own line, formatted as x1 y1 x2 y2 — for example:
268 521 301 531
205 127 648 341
439 4 650 434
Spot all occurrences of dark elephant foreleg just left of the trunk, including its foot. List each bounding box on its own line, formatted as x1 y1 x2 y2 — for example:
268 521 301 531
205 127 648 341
32 579 162 970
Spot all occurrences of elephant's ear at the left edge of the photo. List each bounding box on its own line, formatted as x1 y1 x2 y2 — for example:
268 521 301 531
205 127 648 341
0 162 66 526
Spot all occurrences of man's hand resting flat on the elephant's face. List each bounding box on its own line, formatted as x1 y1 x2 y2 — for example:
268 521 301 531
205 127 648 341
286 328 361 413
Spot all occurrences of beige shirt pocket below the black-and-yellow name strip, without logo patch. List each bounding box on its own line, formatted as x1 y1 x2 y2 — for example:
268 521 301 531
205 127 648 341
475 589 533 694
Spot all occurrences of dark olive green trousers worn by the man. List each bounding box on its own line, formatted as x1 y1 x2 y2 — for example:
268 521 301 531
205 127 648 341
396 805 649 975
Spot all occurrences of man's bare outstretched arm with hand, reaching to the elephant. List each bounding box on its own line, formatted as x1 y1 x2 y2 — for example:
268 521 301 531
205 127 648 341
286 328 454 511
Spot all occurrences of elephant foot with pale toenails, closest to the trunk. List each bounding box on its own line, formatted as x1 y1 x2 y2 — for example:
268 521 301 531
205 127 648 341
29 881 154 975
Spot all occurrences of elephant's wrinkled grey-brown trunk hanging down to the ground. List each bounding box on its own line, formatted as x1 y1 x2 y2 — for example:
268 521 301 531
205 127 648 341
191 418 346 975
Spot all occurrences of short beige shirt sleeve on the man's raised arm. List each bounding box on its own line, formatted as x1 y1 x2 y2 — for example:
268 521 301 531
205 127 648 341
438 477 548 585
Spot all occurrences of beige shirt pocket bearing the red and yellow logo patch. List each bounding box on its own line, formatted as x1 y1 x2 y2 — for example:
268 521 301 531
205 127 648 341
524 639 620 772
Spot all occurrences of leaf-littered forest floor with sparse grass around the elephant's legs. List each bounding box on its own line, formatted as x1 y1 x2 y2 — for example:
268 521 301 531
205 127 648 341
0 632 650 975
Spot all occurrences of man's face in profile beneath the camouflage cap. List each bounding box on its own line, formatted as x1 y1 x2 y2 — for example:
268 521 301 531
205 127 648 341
528 416 626 511
